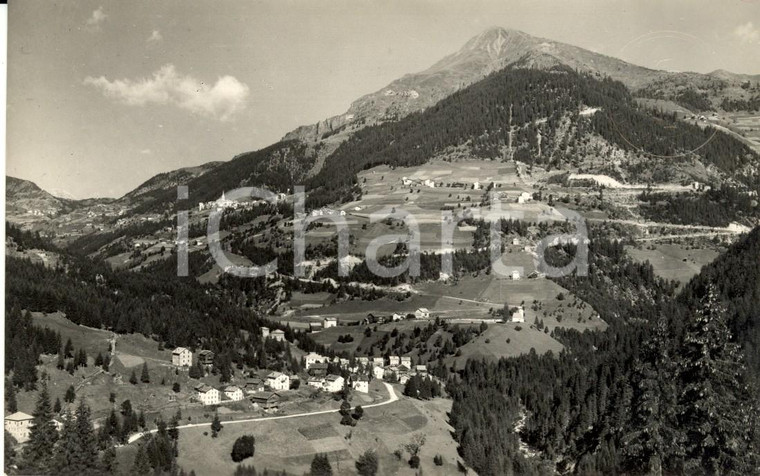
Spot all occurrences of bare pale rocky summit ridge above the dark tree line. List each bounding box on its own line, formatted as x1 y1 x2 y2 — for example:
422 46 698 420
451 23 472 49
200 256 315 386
284 27 760 141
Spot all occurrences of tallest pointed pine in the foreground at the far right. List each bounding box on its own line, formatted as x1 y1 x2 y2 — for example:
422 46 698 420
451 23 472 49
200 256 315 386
678 288 760 474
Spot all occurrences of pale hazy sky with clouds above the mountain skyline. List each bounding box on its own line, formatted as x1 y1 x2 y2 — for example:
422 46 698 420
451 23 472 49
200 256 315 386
6 0 760 198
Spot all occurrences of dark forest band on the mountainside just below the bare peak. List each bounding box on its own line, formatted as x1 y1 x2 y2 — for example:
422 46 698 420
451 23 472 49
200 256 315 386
309 67 753 206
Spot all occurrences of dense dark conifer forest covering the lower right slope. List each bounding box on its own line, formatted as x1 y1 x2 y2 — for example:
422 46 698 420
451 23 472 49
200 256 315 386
449 230 760 475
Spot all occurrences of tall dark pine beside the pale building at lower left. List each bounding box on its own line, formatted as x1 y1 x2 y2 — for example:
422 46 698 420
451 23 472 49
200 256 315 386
23 385 58 472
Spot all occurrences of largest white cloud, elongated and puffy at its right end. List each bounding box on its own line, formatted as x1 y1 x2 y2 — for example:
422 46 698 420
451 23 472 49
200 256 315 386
84 64 249 121
